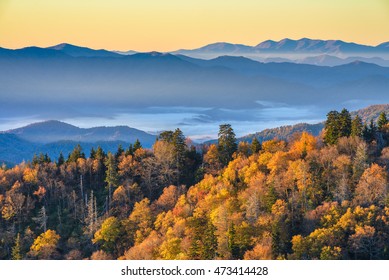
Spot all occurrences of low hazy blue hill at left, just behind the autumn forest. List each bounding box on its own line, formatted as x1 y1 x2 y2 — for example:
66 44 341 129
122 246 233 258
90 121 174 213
0 120 156 165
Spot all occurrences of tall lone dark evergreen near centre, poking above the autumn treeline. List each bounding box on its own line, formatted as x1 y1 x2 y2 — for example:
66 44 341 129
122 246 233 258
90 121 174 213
217 124 238 166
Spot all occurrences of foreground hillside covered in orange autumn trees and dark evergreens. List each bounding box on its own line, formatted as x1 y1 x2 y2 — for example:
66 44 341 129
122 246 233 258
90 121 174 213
0 109 389 259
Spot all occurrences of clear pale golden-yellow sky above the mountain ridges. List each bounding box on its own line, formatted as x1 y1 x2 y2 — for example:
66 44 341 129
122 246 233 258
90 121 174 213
0 0 389 51
